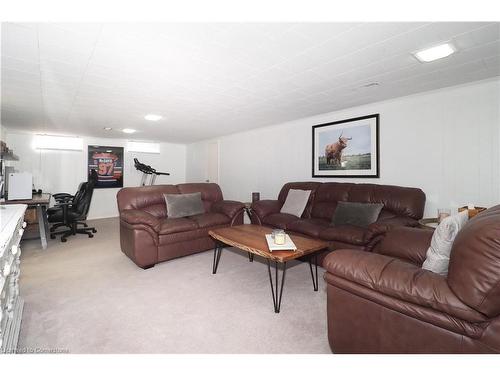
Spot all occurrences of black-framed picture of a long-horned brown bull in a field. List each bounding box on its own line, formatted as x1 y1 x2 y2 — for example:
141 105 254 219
312 113 380 178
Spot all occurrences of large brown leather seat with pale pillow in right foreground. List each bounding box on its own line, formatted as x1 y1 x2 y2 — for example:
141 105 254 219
324 205 500 353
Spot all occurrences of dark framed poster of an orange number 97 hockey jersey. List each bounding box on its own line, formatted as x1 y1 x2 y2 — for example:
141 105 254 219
87 145 123 189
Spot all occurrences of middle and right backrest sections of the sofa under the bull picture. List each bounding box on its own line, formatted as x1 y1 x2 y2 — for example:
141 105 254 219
311 182 425 220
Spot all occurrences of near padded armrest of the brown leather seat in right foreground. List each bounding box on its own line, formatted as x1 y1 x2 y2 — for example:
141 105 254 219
323 250 487 322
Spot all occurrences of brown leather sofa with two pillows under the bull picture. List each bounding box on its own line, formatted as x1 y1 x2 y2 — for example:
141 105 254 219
251 182 425 264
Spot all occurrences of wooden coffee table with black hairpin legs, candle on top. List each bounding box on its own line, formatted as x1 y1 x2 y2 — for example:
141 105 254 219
208 224 328 313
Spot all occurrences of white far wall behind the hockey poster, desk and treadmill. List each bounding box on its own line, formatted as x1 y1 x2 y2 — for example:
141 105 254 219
4 133 186 219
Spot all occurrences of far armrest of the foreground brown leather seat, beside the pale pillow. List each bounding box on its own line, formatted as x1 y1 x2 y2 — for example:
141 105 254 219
374 227 434 266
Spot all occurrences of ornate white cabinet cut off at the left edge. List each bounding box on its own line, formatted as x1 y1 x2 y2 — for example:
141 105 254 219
0 204 27 353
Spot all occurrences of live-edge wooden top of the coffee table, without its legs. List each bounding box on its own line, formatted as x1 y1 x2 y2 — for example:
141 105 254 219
208 224 328 262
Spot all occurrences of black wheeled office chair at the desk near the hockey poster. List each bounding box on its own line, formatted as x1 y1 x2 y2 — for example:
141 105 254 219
47 170 97 242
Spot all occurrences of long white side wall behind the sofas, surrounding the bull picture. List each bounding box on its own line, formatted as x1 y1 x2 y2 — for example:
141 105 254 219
187 79 500 216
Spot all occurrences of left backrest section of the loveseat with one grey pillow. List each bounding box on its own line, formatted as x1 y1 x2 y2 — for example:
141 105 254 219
116 185 179 218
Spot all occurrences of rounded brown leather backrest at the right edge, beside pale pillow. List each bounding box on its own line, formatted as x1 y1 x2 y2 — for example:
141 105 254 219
448 205 500 317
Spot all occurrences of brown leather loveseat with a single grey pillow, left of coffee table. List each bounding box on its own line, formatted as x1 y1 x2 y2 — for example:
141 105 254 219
117 183 244 268
